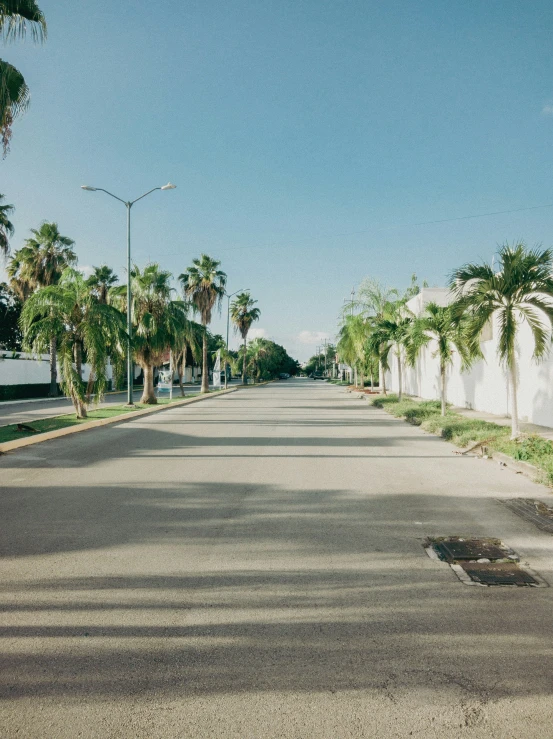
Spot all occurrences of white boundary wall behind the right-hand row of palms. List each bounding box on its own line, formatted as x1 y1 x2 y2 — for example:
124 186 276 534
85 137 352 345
386 288 553 427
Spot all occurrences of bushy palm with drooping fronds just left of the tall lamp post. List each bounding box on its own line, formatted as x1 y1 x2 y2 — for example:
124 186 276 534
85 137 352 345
21 268 125 418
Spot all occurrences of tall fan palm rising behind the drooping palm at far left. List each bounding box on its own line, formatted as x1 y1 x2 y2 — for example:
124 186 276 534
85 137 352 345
7 221 77 397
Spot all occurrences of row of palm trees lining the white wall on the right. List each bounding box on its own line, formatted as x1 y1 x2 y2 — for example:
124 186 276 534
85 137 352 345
337 242 553 439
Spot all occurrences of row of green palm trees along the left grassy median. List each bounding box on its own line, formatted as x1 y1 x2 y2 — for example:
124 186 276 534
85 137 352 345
0 215 266 417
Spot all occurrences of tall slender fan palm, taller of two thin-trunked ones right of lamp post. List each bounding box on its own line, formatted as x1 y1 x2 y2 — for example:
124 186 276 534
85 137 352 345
179 254 227 393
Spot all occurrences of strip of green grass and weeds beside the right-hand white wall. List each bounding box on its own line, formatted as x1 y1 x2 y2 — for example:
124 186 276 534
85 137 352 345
371 395 553 486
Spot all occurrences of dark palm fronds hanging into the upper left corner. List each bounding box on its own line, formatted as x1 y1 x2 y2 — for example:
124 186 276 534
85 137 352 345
0 0 46 157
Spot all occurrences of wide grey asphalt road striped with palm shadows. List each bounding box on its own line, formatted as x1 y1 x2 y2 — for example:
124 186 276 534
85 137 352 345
0 380 553 739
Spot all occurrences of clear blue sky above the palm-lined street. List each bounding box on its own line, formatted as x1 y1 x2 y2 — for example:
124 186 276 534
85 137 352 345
0 0 553 359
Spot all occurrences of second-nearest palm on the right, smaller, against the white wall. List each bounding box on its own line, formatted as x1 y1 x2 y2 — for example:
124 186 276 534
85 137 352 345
407 303 480 416
